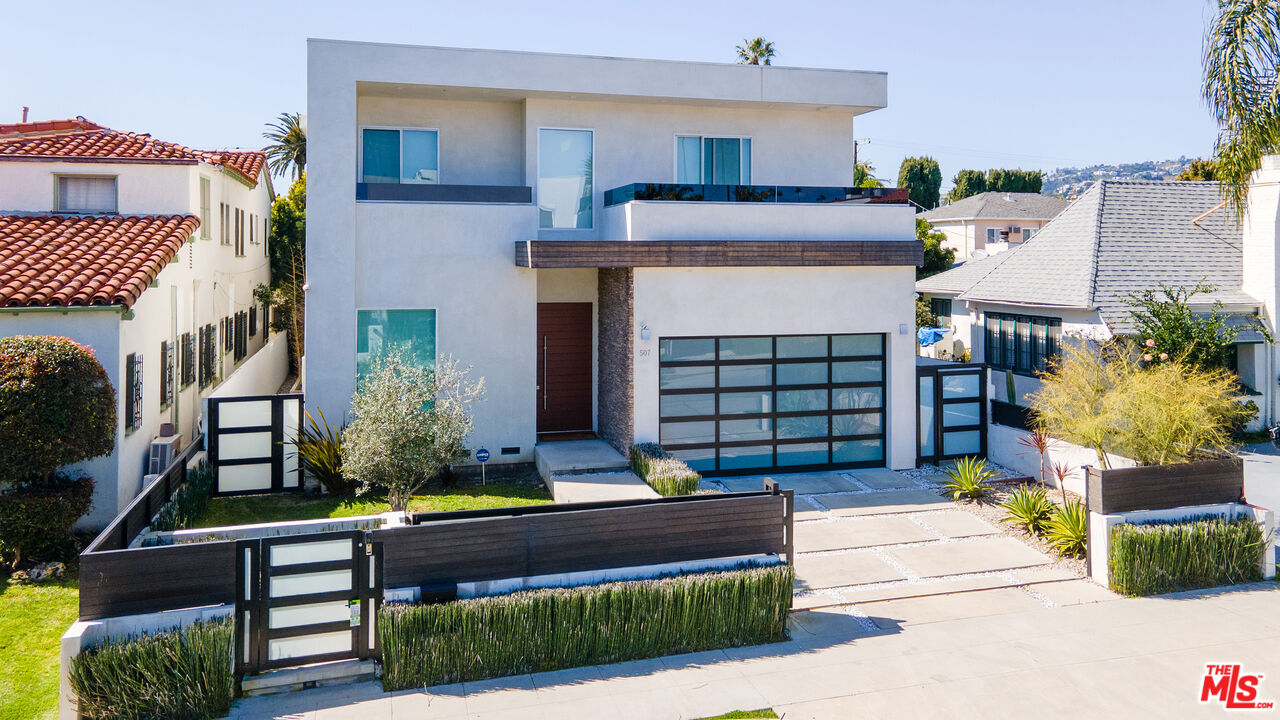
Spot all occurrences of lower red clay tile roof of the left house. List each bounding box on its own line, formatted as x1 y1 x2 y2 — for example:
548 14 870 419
0 210 200 307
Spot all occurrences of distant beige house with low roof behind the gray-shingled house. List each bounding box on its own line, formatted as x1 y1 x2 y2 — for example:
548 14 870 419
918 192 1069 260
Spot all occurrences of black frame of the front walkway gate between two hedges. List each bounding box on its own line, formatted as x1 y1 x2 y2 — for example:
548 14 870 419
236 530 383 674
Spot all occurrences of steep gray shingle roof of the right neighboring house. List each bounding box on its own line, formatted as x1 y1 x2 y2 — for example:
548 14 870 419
916 181 1257 331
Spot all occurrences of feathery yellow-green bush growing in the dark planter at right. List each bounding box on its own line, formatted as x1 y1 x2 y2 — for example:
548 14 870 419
1030 340 1256 468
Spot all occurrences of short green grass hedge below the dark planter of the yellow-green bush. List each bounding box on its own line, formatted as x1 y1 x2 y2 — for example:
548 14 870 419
1107 518 1263 594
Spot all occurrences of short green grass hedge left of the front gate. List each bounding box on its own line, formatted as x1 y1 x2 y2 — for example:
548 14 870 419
69 609 236 720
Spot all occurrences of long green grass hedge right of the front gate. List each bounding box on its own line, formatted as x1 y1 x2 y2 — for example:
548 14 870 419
378 565 794 691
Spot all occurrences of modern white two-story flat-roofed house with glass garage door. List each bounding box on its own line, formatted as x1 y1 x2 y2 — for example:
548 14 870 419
303 40 922 474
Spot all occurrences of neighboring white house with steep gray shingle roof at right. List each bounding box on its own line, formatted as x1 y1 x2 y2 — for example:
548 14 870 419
915 176 1280 425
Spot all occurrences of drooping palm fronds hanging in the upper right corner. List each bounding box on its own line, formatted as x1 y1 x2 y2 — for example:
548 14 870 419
1203 0 1280 217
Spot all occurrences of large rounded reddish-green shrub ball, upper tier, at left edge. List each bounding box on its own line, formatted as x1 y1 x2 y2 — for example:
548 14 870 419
0 336 115 483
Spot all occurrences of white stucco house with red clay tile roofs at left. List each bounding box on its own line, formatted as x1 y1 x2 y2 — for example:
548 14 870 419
0 118 271 527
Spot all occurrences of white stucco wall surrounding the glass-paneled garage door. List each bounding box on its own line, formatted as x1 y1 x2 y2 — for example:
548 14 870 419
634 268 915 469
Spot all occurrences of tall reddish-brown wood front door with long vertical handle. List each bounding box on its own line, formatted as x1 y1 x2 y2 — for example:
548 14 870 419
538 302 591 433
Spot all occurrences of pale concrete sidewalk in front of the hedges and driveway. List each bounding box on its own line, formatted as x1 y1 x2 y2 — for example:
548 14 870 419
232 583 1280 720
